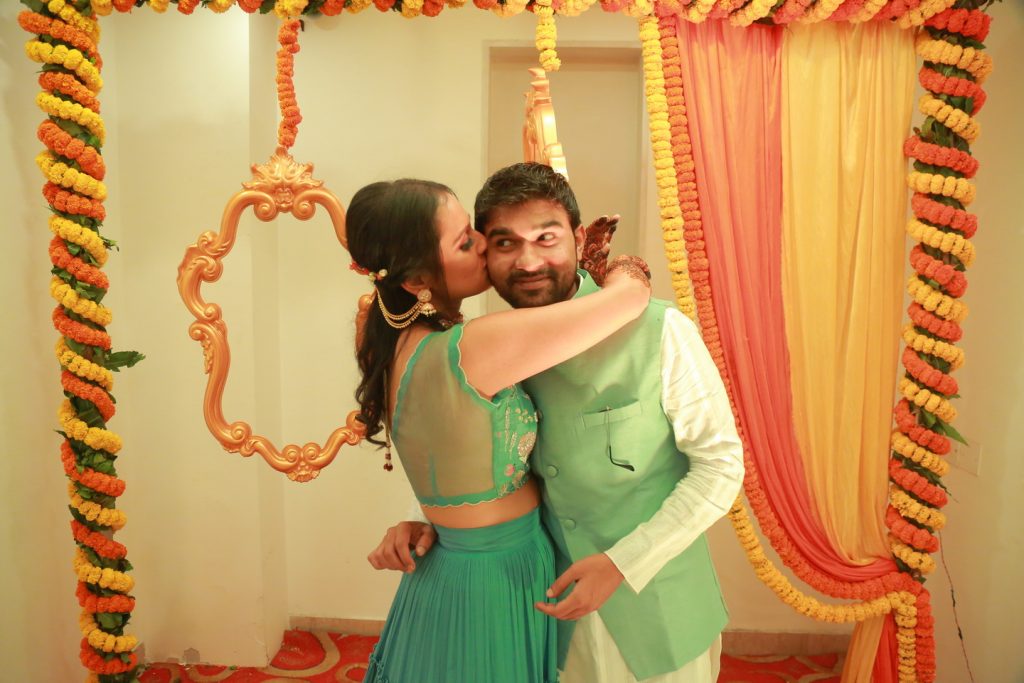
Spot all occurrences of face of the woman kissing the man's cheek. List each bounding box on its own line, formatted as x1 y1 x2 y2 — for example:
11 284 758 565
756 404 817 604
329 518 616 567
434 195 490 306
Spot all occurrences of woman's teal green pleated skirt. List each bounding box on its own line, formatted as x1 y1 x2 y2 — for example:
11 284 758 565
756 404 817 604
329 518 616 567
365 510 558 683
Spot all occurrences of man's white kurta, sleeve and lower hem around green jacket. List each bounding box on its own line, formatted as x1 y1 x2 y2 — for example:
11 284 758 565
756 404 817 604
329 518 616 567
561 308 743 683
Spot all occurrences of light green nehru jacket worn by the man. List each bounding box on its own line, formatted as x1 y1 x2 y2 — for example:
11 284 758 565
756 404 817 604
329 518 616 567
525 271 728 680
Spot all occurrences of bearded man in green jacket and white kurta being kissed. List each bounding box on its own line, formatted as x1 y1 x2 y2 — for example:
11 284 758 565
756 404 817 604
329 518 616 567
371 164 743 683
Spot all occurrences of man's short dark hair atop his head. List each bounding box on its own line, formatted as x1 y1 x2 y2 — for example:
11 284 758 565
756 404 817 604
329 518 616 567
473 162 580 232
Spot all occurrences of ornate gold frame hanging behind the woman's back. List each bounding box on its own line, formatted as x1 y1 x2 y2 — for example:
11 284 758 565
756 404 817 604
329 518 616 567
177 147 369 481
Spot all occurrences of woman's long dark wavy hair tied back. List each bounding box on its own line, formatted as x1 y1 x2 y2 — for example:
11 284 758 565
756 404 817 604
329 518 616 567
345 178 454 445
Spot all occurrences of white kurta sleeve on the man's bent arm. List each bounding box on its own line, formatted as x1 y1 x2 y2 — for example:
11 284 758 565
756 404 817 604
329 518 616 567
606 308 743 593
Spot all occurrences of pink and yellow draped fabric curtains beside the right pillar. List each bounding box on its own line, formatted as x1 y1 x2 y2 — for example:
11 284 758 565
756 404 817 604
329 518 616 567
677 15 913 682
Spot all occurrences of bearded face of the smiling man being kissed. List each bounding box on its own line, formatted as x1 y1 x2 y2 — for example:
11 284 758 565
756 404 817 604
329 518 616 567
483 200 585 308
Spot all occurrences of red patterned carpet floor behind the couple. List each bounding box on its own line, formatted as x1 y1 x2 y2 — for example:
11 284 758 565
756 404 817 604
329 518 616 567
140 631 843 683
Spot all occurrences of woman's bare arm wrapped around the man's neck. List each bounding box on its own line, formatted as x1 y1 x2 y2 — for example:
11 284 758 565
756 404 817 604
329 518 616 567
459 265 650 396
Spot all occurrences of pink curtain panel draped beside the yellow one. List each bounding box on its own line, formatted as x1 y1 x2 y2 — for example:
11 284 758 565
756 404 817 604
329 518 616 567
678 20 896 682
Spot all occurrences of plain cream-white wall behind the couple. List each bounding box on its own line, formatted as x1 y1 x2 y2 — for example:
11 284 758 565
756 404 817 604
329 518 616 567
0 3 1024 683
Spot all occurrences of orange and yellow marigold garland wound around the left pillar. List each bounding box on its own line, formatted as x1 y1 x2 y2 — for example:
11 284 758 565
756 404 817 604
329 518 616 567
18 0 140 683
